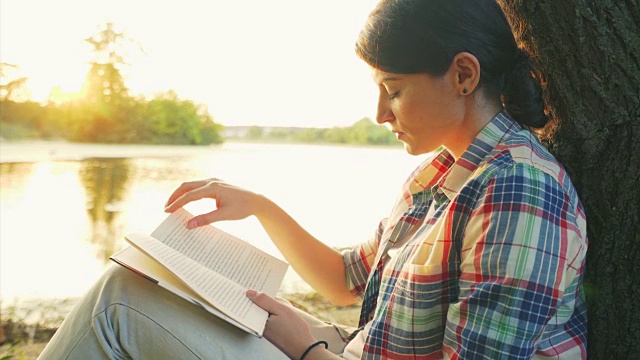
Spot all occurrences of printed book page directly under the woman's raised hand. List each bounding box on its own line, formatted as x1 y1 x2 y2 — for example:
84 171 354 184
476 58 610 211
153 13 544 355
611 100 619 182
151 209 288 296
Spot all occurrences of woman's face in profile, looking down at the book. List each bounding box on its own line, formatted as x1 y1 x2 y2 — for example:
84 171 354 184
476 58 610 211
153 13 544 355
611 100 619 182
372 69 464 155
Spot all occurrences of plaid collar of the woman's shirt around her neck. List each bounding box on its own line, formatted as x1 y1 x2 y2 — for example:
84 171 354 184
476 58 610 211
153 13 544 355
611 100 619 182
403 111 520 205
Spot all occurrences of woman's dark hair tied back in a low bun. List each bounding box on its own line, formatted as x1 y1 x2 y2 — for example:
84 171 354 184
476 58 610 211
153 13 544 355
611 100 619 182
356 0 549 128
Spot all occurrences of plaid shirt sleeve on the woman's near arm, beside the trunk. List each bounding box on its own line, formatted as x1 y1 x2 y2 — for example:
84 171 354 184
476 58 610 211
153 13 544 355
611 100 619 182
443 164 584 359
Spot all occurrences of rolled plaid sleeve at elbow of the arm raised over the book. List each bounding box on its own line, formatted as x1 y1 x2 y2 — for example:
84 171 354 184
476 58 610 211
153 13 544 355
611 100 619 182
342 218 387 296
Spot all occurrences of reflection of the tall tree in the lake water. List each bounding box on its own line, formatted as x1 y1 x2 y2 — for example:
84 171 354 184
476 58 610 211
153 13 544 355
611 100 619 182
78 159 131 263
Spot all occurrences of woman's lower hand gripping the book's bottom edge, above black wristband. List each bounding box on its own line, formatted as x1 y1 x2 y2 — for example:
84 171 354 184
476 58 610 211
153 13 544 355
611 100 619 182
247 290 316 359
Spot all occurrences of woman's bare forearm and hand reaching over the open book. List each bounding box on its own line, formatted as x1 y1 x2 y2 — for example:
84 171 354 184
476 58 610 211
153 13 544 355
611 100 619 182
165 179 356 305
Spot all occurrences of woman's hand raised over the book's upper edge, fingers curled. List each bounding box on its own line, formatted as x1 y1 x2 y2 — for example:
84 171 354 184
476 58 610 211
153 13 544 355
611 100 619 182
164 178 266 229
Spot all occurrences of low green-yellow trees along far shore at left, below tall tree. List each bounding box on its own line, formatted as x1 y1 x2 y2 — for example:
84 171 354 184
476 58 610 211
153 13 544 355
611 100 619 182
0 91 222 145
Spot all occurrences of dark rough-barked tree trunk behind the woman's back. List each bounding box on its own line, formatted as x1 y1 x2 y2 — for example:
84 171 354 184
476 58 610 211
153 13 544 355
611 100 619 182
499 0 640 359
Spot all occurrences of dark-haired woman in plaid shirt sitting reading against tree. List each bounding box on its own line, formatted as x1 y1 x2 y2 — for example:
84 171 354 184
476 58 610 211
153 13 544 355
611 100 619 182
38 0 587 360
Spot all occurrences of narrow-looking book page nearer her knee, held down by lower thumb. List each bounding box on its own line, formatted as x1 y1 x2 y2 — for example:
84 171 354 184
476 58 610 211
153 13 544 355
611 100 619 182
126 234 268 331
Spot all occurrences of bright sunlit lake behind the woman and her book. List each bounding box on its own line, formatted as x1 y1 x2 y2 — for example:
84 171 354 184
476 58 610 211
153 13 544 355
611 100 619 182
0 141 422 304
